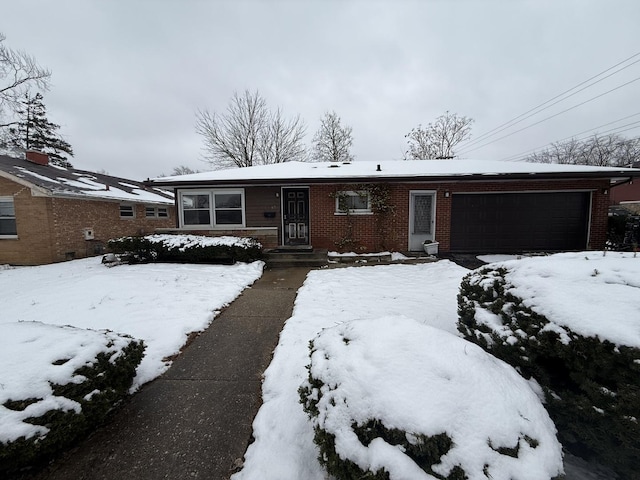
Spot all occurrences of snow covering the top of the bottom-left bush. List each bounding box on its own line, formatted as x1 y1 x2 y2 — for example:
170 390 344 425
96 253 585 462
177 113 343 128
0 322 132 443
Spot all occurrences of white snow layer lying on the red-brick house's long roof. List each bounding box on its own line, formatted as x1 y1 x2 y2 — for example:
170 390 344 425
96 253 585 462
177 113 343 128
153 159 637 182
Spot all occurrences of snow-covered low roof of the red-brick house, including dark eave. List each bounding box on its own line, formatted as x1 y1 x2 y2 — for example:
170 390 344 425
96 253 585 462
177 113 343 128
149 160 640 187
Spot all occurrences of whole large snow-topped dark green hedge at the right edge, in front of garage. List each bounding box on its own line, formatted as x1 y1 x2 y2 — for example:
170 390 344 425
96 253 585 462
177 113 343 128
458 252 640 479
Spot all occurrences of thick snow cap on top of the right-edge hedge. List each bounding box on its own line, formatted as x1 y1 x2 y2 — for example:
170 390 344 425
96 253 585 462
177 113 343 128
492 252 640 348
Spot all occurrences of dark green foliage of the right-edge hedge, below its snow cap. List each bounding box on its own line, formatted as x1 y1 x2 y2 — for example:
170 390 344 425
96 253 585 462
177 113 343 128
458 265 640 479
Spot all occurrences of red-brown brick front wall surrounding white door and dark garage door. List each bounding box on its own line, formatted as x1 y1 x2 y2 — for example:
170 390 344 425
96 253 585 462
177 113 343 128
310 179 609 253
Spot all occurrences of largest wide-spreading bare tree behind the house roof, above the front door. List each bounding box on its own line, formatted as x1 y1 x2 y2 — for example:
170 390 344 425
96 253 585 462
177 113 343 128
196 90 305 168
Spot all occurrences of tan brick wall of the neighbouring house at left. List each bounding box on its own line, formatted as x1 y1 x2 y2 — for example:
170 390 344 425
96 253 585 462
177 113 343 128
0 177 176 265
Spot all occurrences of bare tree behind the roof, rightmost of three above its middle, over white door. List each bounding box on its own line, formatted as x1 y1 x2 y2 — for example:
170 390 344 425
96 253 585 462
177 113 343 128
405 111 473 160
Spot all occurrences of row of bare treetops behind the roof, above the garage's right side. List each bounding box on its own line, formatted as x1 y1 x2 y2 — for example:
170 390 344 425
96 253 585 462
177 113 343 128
526 134 640 167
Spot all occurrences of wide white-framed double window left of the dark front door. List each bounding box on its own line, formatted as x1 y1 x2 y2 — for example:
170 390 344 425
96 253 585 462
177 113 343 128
180 190 244 228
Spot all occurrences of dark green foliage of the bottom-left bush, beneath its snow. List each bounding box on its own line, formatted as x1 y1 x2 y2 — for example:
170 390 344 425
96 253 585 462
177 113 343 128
0 326 145 475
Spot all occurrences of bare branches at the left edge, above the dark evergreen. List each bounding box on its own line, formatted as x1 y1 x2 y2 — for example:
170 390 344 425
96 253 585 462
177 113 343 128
0 33 51 127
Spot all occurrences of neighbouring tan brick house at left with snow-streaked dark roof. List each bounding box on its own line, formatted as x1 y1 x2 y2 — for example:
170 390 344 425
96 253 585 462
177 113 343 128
0 151 176 265
